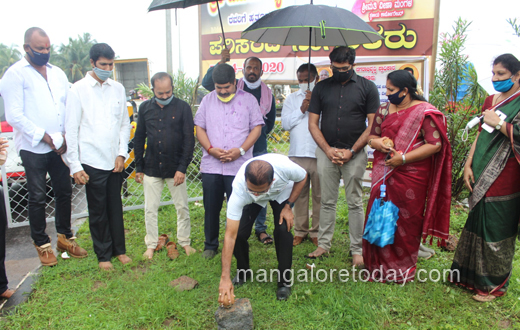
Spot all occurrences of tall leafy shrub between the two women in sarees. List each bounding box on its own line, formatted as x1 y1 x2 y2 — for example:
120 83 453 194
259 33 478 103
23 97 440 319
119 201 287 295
430 18 488 200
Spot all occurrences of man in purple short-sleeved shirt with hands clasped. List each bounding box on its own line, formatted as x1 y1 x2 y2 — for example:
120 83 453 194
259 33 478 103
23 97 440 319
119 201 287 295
194 64 264 259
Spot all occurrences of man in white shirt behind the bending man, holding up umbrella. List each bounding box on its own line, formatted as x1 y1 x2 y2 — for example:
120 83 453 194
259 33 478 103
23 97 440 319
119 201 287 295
282 63 321 246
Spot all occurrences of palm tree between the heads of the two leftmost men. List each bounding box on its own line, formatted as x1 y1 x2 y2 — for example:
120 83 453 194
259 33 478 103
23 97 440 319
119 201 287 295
53 33 96 83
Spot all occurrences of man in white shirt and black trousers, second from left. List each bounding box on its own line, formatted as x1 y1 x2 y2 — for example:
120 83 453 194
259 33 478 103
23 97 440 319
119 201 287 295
65 43 132 270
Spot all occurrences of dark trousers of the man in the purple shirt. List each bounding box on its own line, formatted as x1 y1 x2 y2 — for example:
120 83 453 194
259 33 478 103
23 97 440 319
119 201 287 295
202 173 235 251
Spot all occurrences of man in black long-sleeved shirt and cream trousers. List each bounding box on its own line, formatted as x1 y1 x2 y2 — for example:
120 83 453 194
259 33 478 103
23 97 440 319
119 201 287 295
134 72 196 259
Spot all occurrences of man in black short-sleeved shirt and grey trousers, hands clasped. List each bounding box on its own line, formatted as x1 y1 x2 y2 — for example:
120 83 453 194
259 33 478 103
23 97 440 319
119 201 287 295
308 47 379 266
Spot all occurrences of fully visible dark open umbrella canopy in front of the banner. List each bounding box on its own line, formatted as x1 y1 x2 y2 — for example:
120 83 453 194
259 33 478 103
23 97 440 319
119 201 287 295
242 4 383 46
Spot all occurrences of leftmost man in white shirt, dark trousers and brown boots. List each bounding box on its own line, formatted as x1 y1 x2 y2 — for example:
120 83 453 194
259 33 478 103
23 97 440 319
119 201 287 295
0 27 87 266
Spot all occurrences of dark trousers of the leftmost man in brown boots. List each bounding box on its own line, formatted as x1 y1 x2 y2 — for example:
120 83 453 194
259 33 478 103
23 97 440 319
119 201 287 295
20 150 72 246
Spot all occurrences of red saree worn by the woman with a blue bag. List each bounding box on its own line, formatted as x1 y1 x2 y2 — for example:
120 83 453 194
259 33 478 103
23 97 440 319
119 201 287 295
363 102 451 282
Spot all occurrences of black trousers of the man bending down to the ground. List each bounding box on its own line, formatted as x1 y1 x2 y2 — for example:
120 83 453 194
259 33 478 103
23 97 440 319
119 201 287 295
233 201 293 287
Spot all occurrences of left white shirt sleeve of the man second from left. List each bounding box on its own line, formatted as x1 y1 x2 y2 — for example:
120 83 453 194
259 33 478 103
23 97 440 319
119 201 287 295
65 87 83 175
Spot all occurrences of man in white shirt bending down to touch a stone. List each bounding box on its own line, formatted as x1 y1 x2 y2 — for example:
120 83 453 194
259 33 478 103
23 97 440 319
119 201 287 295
219 154 307 305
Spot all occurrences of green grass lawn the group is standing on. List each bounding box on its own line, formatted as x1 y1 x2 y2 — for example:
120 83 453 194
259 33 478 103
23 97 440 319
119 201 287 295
0 189 520 329
